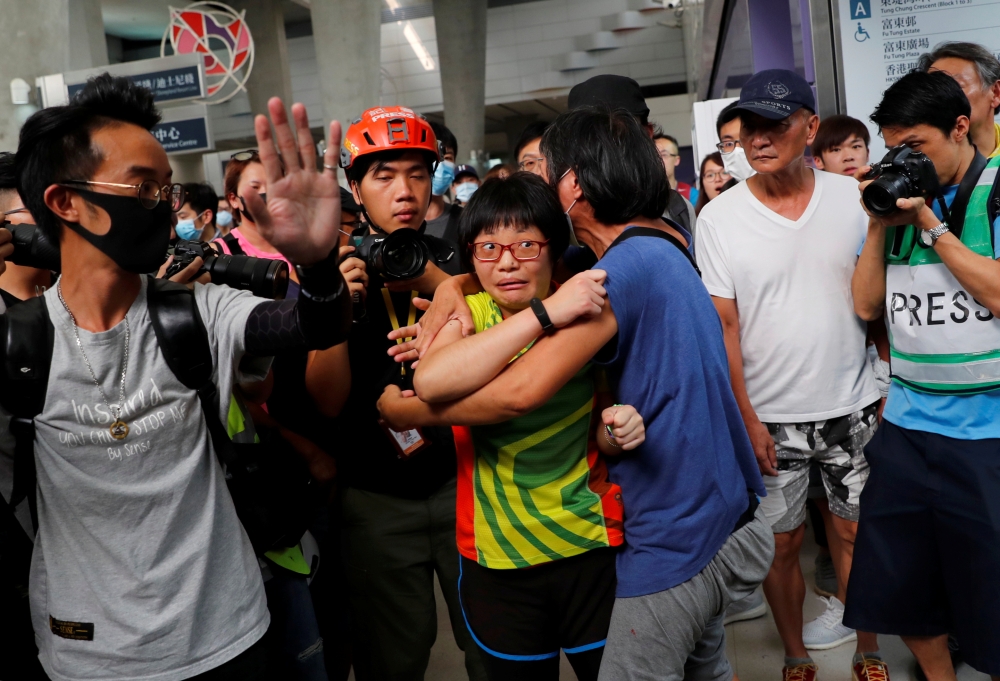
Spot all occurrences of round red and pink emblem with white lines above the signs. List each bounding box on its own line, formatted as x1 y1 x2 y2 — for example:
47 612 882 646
160 2 254 104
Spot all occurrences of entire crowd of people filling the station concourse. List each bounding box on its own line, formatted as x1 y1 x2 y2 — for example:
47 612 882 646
0 33 1000 681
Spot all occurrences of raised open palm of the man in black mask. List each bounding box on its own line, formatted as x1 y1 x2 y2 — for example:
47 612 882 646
243 97 340 265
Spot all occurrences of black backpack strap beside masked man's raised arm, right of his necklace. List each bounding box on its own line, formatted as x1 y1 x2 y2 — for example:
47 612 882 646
146 274 235 464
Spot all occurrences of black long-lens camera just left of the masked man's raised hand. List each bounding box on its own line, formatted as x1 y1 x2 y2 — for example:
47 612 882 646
166 239 288 300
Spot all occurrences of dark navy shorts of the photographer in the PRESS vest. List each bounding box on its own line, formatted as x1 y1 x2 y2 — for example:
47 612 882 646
844 420 1000 675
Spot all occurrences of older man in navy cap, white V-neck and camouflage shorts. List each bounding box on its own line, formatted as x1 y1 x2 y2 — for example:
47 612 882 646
696 69 887 681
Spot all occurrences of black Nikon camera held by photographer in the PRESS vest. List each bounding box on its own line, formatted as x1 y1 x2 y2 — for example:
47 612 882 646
861 144 940 215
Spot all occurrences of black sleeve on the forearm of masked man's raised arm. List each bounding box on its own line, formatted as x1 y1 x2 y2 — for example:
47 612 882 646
246 251 351 356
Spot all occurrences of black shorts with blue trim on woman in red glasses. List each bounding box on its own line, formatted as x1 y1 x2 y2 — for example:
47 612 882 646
458 548 616 662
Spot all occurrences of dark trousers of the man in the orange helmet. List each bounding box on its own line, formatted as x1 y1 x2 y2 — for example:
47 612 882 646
341 480 486 681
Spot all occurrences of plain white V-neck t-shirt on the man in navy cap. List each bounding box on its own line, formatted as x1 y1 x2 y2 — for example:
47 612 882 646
695 171 879 423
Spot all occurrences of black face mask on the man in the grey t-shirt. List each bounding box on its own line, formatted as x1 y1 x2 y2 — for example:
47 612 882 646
66 189 171 274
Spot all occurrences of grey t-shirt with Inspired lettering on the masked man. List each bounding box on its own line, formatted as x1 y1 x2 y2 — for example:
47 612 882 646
29 277 270 681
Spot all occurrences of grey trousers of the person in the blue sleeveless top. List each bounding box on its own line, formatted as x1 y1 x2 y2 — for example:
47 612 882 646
598 508 774 681
